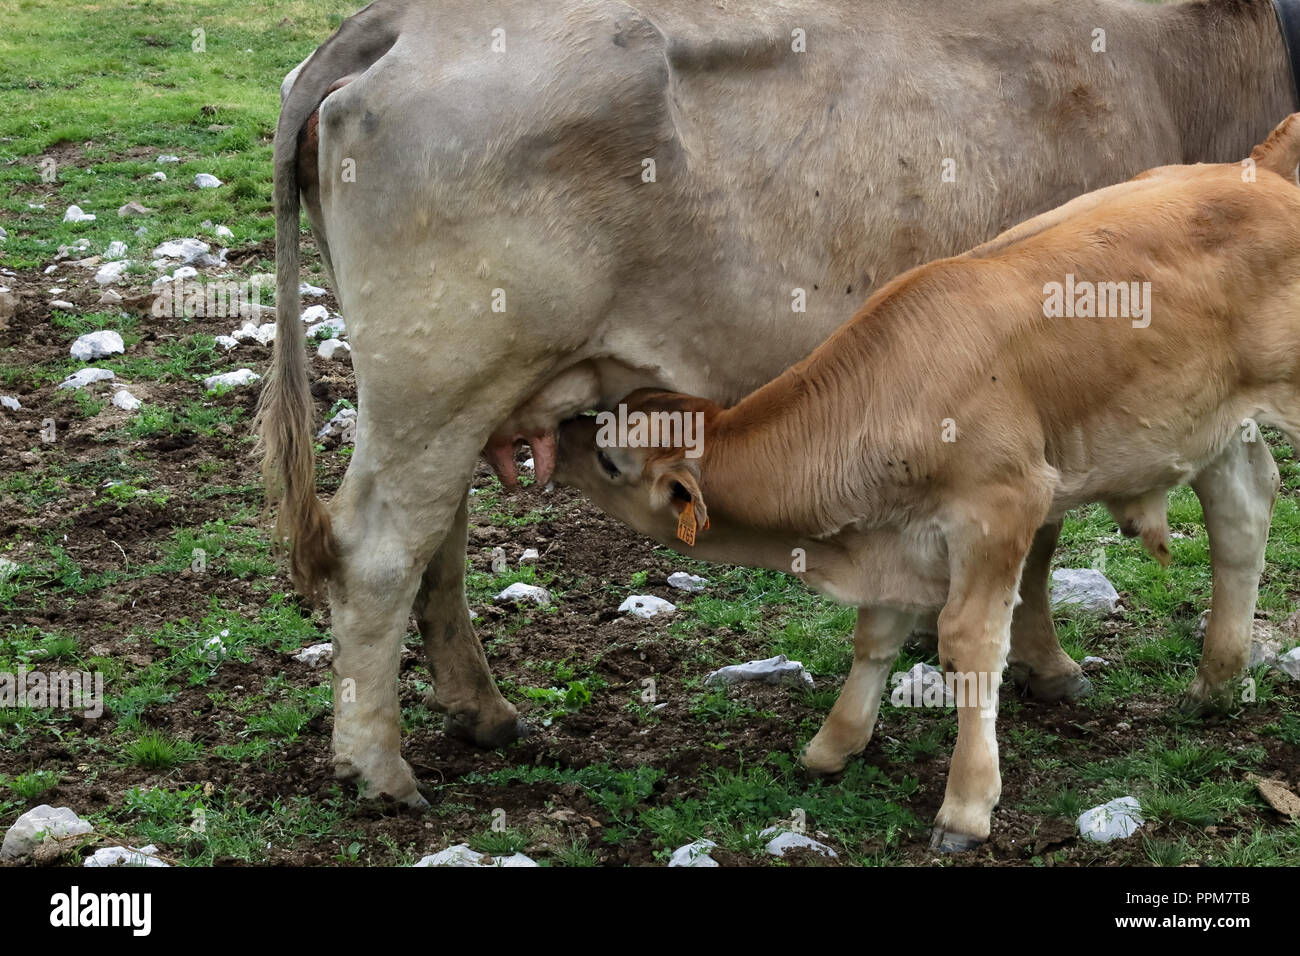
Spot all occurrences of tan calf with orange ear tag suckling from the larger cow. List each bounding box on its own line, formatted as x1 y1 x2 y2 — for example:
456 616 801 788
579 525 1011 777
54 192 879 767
556 114 1300 851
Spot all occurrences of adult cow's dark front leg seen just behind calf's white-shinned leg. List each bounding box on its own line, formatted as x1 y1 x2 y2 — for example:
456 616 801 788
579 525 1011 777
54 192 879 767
1008 520 1092 701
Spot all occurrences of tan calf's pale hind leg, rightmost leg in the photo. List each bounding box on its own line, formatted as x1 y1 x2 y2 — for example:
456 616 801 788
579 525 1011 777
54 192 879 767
1183 441 1281 710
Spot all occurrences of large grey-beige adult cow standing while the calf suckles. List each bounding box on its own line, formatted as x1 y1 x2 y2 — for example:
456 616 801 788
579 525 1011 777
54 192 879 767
260 0 1296 803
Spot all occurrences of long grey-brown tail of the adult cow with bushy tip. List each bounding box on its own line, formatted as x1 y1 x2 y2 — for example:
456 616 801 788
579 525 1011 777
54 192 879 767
254 3 402 596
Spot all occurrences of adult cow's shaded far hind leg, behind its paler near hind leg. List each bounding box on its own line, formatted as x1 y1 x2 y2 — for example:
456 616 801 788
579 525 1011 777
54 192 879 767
415 494 527 747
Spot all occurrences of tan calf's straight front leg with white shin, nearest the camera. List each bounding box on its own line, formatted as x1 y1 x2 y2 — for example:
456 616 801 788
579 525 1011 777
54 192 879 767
930 502 1045 852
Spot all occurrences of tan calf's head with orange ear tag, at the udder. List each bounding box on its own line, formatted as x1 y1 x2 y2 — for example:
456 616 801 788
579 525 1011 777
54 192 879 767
555 389 720 545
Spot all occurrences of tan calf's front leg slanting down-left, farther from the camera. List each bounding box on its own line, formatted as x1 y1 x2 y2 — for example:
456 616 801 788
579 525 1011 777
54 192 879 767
802 607 917 774
